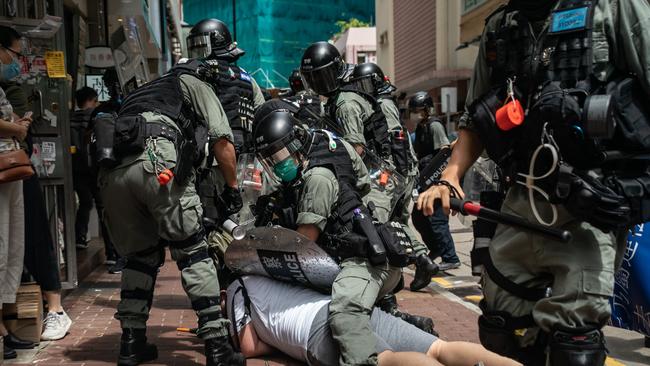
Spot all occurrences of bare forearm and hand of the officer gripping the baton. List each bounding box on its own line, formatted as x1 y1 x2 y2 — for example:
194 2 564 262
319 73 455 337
417 129 483 216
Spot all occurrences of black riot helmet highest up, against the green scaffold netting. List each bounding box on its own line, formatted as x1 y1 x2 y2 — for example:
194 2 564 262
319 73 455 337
187 19 244 60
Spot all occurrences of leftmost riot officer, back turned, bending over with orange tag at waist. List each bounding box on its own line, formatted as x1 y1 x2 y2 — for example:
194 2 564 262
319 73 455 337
96 60 243 365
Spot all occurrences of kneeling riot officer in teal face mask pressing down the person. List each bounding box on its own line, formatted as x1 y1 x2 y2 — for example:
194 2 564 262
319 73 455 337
254 110 400 365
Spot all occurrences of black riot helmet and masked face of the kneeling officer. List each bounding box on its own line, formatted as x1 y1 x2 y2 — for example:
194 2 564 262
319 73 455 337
253 108 307 183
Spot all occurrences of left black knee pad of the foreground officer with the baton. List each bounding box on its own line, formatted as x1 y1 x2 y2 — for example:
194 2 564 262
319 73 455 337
478 311 546 366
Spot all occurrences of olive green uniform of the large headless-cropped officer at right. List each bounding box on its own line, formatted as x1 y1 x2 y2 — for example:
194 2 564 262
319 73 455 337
465 0 650 346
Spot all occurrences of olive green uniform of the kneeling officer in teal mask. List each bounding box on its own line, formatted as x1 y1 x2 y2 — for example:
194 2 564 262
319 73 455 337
296 138 401 365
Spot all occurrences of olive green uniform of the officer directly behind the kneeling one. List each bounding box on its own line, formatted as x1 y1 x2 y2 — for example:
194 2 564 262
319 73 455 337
335 91 399 223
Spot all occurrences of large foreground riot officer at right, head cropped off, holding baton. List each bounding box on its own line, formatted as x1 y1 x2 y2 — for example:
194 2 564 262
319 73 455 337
418 0 650 365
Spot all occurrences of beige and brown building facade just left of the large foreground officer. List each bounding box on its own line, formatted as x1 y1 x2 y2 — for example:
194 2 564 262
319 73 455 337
375 0 504 120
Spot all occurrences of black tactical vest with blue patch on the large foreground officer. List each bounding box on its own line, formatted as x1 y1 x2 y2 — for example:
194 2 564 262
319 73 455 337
470 0 600 171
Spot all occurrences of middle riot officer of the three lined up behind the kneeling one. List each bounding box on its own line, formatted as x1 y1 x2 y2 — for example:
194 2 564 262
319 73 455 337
349 62 438 291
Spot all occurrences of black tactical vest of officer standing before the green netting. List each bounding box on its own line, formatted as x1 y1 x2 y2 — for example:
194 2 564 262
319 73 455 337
206 60 255 153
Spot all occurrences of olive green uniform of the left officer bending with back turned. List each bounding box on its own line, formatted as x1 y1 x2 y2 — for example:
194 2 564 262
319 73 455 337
99 75 233 339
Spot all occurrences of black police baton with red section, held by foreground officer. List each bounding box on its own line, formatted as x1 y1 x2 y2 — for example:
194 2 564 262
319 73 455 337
450 197 571 243
